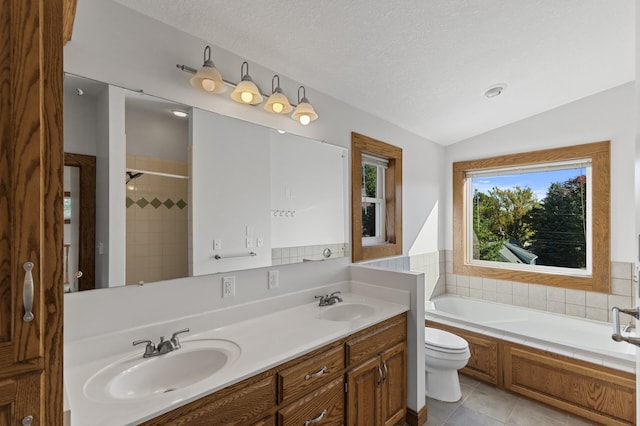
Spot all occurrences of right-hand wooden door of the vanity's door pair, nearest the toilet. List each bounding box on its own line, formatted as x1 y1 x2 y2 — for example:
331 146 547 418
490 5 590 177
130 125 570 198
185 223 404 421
380 343 407 426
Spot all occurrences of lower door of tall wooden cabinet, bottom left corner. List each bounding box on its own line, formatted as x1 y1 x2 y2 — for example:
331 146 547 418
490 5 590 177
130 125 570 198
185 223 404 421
0 373 44 425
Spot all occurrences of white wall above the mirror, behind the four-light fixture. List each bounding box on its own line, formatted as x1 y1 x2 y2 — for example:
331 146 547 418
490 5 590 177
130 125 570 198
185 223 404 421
64 0 444 262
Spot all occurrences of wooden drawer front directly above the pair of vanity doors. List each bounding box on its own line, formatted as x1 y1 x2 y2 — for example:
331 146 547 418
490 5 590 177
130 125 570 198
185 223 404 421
346 314 407 366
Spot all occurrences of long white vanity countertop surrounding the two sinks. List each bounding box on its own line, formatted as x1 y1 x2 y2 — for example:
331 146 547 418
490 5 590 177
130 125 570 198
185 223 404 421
64 293 409 426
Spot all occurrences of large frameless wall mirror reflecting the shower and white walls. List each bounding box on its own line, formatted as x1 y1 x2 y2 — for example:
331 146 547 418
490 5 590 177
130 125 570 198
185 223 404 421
64 74 349 292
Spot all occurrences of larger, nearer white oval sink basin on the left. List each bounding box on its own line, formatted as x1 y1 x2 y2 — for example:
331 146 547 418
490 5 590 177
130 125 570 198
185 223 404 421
84 339 240 401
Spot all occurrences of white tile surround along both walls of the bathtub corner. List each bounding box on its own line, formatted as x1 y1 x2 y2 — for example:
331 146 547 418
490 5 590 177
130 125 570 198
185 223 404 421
366 250 635 322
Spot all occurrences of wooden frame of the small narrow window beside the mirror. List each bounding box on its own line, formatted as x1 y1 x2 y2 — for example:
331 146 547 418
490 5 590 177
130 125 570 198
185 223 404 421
351 132 402 262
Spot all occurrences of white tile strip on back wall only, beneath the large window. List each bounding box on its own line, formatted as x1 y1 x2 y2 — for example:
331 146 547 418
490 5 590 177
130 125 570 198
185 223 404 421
445 250 635 324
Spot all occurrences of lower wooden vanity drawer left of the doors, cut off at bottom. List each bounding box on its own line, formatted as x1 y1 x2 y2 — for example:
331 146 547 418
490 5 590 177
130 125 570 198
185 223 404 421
278 376 344 426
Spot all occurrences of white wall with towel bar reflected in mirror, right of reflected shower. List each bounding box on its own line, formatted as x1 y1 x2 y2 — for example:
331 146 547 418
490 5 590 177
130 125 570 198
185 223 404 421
189 108 271 275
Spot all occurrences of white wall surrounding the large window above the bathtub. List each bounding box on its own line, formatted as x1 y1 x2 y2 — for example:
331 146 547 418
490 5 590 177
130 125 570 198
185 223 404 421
444 83 636 262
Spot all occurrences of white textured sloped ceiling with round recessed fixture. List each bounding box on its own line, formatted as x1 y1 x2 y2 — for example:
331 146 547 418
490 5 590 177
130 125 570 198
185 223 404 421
111 0 635 145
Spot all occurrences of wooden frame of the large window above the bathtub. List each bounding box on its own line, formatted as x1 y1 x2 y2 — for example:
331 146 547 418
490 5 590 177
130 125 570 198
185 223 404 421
453 141 611 293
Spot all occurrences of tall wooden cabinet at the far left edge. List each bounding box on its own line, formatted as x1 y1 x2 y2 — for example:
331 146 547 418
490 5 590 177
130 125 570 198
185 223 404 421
0 0 75 426
